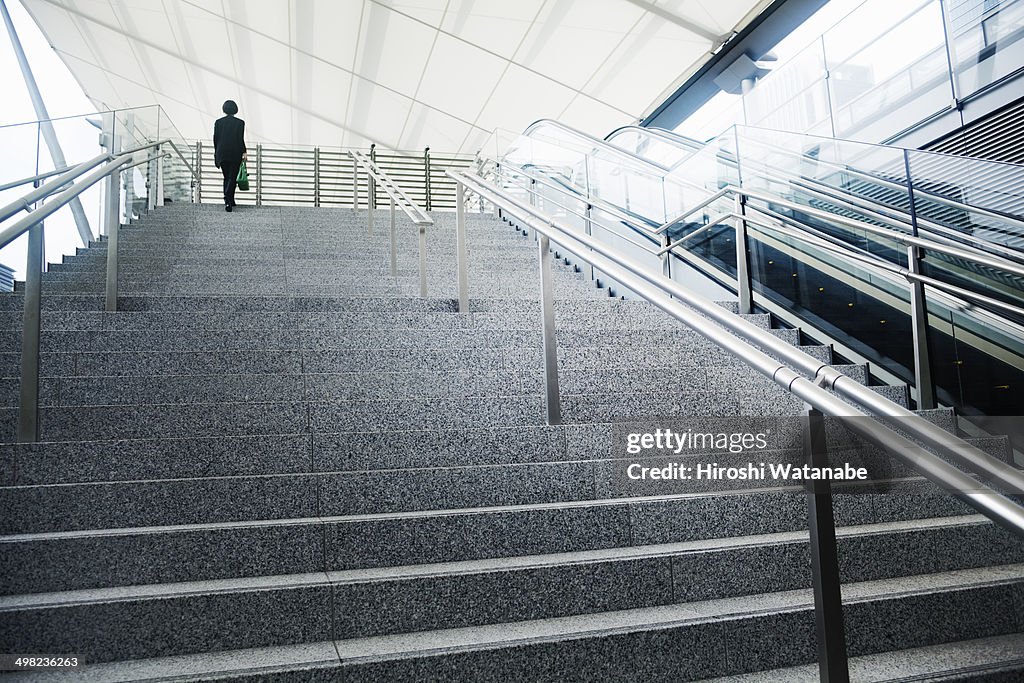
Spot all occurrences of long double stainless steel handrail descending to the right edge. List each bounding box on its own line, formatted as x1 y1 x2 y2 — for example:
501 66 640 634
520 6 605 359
451 167 1024 536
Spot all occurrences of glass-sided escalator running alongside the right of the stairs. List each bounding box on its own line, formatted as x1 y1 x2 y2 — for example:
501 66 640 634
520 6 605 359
493 121 1024 449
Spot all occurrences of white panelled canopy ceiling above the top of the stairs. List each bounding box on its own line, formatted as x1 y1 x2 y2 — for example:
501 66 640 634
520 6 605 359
23 0 770 153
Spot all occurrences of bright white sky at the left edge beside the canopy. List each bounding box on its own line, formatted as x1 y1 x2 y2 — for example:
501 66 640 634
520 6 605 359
0 0 100 279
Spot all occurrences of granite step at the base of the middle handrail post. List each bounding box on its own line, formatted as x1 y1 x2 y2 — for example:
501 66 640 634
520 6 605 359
0 389 856 441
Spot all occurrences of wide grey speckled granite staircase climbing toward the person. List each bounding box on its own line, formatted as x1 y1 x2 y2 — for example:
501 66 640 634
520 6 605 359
0 205 1024 681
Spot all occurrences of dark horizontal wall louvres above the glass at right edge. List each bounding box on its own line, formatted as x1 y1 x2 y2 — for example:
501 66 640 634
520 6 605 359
923 97 1024 164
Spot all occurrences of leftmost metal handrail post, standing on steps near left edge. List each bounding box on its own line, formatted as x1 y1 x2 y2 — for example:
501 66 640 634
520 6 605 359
17 221 45 443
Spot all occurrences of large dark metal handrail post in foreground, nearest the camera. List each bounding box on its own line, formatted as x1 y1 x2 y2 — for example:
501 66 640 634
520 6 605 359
804 405 850 683
